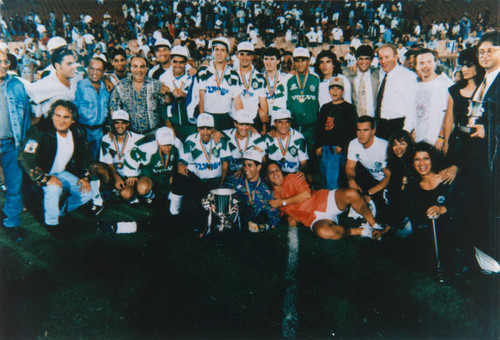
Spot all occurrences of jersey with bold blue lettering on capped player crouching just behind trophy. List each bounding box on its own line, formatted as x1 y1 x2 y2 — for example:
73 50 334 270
182 133 231 179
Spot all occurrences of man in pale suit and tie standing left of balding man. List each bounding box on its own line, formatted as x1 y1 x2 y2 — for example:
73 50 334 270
347 45 379 117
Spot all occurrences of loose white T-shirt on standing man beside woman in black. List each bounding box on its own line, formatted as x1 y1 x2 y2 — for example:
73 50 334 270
415 74 453 145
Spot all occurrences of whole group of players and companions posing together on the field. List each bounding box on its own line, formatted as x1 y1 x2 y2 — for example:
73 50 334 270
0 3 500 276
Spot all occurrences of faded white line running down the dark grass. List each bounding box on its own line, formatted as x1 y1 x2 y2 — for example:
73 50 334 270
281 227 299 338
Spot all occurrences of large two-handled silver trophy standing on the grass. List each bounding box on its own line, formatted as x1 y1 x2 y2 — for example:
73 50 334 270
202 188 238 235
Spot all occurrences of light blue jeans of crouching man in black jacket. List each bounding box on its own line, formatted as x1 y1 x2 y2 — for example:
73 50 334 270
43 171 92 225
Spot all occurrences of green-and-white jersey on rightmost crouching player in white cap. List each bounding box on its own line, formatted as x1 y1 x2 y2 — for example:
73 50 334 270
258 129 309 172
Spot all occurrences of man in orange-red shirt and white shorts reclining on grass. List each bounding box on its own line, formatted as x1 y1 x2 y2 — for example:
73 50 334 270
264 161 389 240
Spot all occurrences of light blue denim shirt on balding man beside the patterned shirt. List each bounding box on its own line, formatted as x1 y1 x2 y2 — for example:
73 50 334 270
74 78 109 126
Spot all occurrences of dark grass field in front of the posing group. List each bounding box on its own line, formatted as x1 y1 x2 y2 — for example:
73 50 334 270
0 194 500 339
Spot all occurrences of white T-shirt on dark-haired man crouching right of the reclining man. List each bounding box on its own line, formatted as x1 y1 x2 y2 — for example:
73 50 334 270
347 137 388 181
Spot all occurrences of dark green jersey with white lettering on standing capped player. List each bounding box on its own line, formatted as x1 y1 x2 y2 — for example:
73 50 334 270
286 72 320 126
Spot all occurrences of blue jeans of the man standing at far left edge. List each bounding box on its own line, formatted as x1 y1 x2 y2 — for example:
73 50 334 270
0 138 23 228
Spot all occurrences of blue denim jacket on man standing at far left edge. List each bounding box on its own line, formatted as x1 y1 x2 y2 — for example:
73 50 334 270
4 74 31 149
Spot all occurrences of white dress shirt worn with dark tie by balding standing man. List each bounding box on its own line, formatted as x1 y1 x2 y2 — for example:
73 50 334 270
379 65 417 132
